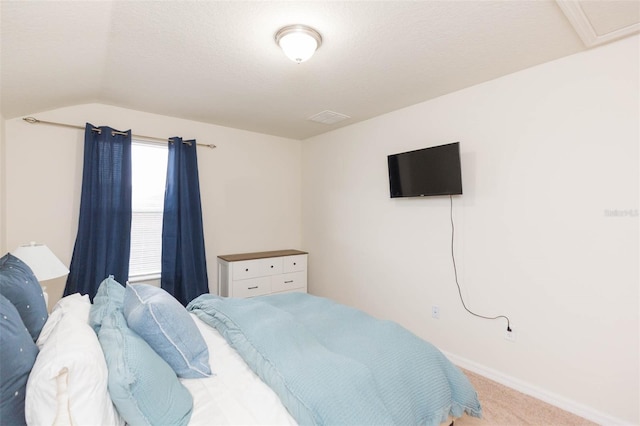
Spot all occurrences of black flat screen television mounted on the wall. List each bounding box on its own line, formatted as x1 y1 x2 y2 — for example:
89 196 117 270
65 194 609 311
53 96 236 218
387 142 462 198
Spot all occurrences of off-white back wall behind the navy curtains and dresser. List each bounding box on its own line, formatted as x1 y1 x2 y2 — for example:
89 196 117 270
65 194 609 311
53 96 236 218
3 104 302 306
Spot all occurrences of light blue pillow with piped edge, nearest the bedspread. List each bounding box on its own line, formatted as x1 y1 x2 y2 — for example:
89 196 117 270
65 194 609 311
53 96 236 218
123 284 211 379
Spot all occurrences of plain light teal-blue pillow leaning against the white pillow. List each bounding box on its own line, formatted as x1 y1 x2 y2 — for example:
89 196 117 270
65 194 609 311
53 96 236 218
98 310 193 425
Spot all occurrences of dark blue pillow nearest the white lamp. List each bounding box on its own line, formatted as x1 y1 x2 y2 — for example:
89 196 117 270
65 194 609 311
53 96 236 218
0 253 49 342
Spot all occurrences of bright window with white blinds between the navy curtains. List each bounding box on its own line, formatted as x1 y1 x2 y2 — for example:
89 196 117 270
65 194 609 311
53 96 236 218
129 141 168 281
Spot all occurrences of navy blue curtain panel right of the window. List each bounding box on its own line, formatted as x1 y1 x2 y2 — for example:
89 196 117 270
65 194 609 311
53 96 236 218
160 137 209 306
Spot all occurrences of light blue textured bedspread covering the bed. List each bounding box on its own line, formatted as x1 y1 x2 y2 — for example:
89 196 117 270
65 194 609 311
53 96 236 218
187 293 481 426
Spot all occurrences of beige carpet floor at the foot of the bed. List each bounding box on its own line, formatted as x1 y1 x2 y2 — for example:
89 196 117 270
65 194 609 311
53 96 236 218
455 370 595 426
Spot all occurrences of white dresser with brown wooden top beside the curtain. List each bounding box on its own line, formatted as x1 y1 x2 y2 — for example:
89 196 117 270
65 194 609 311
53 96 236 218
218 250 308 297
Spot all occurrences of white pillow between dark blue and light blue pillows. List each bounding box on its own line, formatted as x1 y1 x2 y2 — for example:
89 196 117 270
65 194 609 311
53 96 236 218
25 304 124 425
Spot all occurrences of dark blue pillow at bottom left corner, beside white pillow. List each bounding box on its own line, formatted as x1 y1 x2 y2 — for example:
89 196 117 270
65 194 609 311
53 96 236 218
0 295 38 425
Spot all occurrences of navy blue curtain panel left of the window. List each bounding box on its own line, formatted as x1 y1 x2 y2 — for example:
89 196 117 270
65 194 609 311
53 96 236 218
64 123 131 300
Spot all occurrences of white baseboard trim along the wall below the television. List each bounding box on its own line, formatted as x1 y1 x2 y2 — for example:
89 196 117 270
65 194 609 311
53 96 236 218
442 351 633 426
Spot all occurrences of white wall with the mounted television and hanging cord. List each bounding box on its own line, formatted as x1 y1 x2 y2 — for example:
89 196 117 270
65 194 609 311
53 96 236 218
303 36 640 424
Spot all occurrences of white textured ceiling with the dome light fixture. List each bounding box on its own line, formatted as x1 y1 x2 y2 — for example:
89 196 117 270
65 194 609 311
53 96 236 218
0 0 640 139
